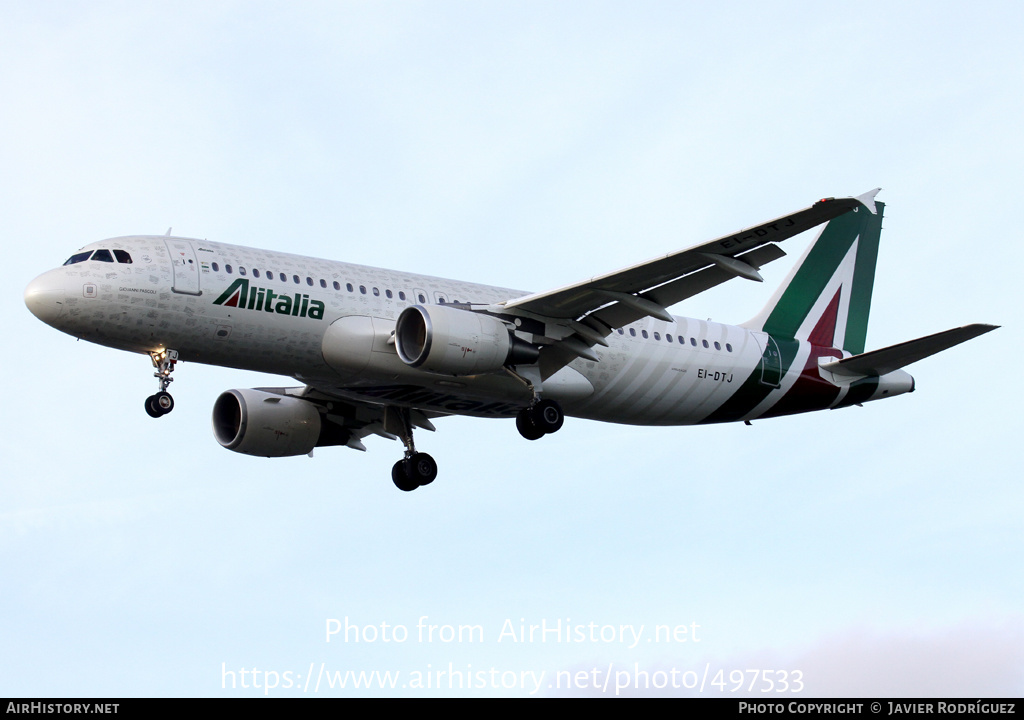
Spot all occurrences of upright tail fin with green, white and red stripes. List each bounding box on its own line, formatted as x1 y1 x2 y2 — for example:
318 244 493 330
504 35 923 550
743 188 885 354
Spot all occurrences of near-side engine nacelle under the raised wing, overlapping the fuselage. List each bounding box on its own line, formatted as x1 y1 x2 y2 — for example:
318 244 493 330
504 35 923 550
394 305 540 375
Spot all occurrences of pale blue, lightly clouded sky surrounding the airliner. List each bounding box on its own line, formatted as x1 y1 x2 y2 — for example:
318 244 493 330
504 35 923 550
0 0 1024 700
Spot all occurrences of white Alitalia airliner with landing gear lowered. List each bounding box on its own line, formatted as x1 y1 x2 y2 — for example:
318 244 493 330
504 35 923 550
25 189 996 492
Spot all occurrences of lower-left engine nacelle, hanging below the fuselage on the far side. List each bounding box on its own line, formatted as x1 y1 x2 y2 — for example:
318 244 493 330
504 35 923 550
213 390 321 458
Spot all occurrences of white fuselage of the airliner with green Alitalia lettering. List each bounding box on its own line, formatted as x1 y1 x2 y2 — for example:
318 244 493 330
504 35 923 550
26 236 905 425
